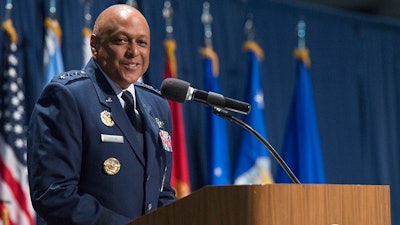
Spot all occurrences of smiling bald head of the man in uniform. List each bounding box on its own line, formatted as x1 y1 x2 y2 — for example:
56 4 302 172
90 5 150 89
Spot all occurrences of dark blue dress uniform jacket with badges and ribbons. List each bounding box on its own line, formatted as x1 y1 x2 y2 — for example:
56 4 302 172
28 60 175 225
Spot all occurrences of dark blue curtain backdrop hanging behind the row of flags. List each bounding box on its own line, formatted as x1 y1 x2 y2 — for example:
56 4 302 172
0 0 400 225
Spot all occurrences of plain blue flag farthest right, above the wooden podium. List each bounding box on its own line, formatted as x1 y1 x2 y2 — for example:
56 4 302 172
275 49 326 183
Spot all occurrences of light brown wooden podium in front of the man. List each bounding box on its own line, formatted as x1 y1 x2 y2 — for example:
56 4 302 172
129 184 391 225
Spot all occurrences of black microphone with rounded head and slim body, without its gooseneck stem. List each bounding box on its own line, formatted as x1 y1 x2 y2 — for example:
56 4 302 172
161 78 251 114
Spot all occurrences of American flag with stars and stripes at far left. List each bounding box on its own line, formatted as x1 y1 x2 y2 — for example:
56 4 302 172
0 20 35 225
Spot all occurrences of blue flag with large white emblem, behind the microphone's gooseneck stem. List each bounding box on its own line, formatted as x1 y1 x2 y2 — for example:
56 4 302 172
234 41 273 184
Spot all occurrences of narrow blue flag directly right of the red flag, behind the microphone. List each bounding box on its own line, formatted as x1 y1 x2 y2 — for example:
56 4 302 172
203 47 231 185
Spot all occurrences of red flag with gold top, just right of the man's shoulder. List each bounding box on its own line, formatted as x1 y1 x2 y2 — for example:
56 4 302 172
164 39 190 198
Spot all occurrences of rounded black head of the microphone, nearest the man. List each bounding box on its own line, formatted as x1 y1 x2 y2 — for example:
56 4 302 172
160 78 190 102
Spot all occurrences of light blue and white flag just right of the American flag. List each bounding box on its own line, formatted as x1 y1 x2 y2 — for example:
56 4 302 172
43 18 64 84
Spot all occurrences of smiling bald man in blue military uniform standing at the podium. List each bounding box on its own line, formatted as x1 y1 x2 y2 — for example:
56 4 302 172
28 4 175 225
